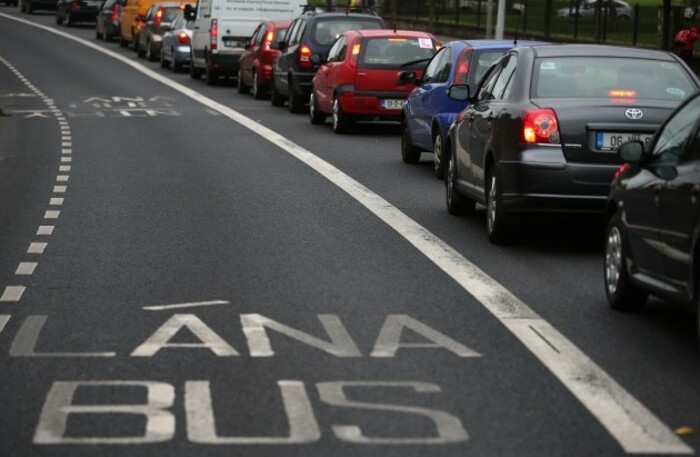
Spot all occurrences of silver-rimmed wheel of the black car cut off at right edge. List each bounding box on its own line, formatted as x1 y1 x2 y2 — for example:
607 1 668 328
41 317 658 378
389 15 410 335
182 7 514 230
604 213 649 311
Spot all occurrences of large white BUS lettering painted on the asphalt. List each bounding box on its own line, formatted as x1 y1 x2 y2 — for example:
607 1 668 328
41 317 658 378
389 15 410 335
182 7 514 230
34 380 469 446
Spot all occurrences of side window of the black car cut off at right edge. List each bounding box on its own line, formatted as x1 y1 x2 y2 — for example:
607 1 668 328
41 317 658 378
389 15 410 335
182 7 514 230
652 98 700 165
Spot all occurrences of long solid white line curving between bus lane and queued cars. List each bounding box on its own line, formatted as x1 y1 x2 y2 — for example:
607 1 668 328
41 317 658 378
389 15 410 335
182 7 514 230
0 13 693 454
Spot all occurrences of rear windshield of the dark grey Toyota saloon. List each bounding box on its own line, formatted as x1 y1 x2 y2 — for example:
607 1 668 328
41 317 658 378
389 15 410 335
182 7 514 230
531 57 697 100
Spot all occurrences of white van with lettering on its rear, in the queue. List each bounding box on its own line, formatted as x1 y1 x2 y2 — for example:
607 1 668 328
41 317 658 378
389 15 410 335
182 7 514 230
185 0 303 85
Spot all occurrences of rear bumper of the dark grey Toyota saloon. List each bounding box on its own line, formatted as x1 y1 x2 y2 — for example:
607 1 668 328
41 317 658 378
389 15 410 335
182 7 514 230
498 147 619 213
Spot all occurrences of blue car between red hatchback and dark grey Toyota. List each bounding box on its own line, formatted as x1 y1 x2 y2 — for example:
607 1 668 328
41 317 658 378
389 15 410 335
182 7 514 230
401 40 543 179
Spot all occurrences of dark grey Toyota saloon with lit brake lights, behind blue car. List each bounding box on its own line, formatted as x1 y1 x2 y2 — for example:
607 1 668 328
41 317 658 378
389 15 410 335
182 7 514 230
445 45 700 243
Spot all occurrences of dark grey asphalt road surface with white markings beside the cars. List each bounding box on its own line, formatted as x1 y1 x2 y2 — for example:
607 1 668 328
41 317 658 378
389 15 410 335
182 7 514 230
0 7 700 457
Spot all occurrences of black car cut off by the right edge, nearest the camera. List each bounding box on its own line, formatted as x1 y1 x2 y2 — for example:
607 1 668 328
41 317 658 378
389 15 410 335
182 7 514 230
604 94 700 341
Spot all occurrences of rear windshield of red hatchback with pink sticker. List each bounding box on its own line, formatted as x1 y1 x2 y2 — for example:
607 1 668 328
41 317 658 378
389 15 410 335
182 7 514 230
358 37 436 69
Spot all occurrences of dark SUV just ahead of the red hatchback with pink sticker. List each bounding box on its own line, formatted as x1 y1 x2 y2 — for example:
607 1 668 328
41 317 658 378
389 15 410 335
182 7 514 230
270 7 386 113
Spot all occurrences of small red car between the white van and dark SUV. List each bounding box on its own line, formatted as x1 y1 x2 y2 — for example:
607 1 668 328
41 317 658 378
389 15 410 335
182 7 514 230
238 21 291 100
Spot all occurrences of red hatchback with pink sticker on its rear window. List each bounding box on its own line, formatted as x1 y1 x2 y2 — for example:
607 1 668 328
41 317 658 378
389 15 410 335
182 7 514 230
309 30 440 133
